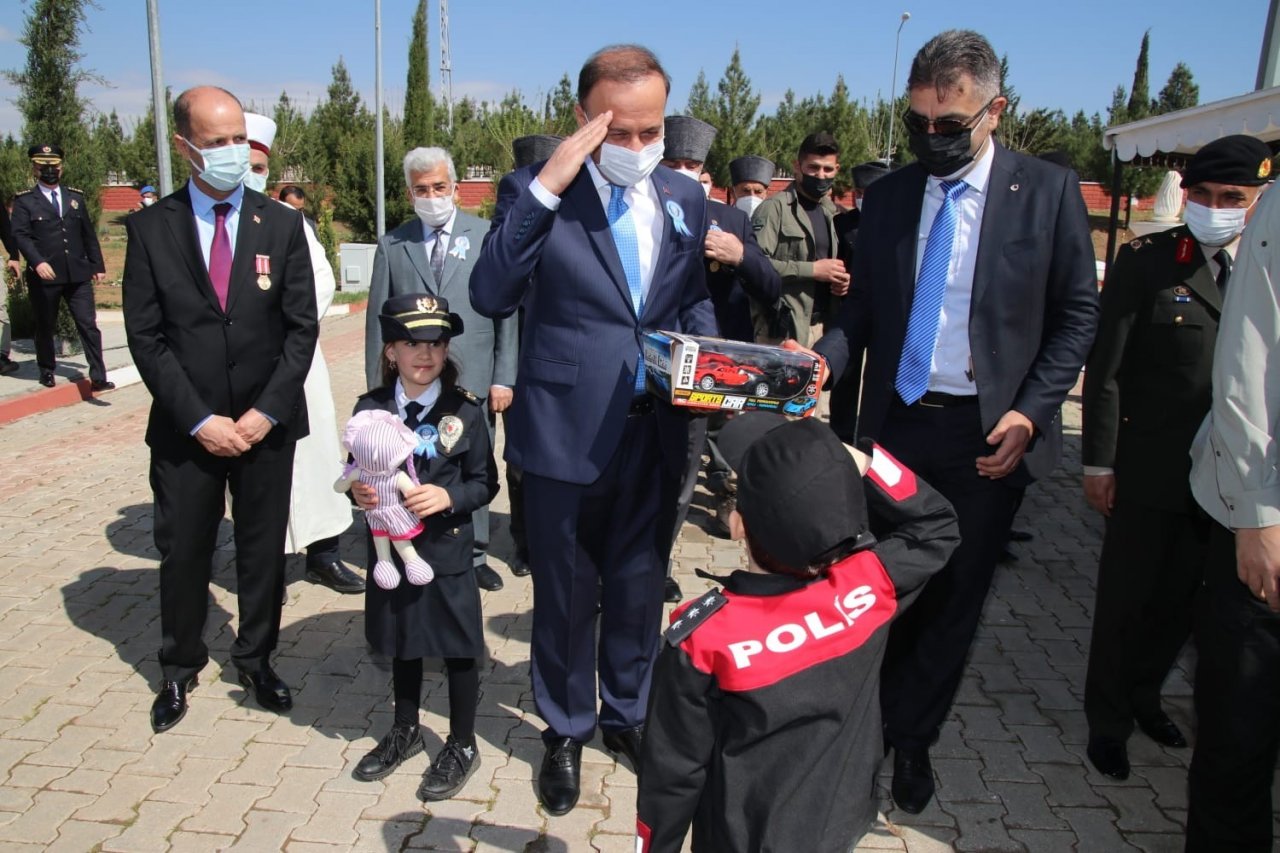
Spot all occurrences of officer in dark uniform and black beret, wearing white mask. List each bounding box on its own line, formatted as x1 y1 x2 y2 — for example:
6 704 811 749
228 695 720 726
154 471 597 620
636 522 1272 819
1083 136 1271 779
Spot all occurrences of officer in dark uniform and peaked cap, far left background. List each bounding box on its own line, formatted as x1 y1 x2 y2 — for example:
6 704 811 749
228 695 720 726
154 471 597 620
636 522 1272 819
13 145 115 391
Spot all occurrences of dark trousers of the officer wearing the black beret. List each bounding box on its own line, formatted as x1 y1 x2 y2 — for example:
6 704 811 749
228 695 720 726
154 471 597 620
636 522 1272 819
1084 496 1208 740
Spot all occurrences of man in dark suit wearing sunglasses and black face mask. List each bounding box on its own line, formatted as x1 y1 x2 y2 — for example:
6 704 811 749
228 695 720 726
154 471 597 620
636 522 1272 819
815 31 1097 813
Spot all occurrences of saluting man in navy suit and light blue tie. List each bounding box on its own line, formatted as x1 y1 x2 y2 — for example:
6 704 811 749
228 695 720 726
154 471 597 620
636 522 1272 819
471 45 716 815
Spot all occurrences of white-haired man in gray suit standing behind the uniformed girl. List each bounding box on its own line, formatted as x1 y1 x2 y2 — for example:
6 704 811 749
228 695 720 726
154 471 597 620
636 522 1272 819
365 149 516 590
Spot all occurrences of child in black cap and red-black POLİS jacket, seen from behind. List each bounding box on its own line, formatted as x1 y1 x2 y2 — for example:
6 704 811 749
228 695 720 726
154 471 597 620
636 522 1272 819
636 412 960 853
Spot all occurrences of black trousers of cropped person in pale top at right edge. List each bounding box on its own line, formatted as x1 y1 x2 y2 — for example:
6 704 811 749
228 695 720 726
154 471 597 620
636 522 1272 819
1187 523 1280 853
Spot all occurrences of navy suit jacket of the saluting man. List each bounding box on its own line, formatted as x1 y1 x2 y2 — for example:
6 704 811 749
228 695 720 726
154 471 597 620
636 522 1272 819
471 164 716 484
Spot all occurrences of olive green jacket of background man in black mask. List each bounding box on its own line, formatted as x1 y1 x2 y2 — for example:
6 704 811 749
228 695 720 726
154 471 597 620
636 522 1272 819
751 186 840 346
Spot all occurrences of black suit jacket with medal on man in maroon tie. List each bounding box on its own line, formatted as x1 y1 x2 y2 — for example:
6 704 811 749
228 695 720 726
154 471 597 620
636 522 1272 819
124 186 319 452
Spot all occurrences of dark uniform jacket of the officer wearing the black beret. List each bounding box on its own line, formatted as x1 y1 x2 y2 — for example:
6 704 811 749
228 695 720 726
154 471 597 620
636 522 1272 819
1082 225 1222 512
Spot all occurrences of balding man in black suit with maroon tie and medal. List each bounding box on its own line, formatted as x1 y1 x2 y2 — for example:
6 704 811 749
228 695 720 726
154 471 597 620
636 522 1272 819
124 86 319 731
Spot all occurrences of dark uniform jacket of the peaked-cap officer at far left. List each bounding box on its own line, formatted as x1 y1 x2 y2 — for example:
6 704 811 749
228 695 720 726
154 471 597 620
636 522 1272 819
12 187 105 284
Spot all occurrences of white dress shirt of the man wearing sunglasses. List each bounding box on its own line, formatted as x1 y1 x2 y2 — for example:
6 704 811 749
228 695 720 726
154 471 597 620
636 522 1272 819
915 138 996 396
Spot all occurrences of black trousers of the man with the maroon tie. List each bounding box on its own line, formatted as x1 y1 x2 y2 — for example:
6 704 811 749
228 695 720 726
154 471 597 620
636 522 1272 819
151 437 294 680
